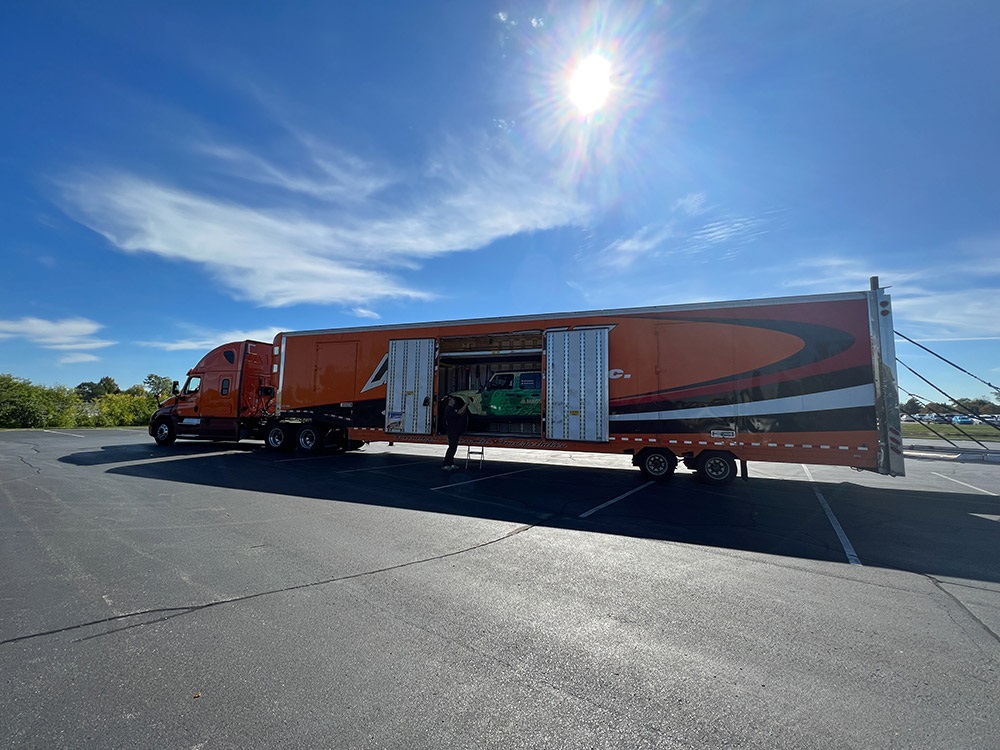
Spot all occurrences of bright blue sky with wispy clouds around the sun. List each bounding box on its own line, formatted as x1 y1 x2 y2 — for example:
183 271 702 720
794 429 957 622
0 0 1000 408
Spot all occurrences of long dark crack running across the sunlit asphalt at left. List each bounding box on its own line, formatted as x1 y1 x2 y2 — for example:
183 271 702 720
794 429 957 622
0 524 537 646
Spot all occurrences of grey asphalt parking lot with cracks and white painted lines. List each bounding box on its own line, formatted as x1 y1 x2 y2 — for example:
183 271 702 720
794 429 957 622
0 430 1000 748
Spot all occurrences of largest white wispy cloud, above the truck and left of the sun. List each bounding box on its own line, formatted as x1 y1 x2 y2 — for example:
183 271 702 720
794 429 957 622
57 134 586 308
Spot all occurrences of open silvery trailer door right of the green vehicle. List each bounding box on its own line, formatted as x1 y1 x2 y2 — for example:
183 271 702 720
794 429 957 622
545 328 608 443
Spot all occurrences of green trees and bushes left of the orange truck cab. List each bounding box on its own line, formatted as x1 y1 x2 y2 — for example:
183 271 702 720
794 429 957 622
0 373 173 429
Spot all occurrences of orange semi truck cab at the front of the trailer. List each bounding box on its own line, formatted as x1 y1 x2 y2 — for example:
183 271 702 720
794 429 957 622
149 341 274 445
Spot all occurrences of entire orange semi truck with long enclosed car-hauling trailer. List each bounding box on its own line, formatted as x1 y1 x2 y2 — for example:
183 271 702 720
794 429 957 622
149 277 904 484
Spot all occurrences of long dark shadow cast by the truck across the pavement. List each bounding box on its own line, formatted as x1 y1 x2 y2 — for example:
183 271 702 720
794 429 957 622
60 443 1000 583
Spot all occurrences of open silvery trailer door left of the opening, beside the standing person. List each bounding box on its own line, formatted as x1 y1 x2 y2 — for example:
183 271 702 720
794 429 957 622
385 339 436 435
